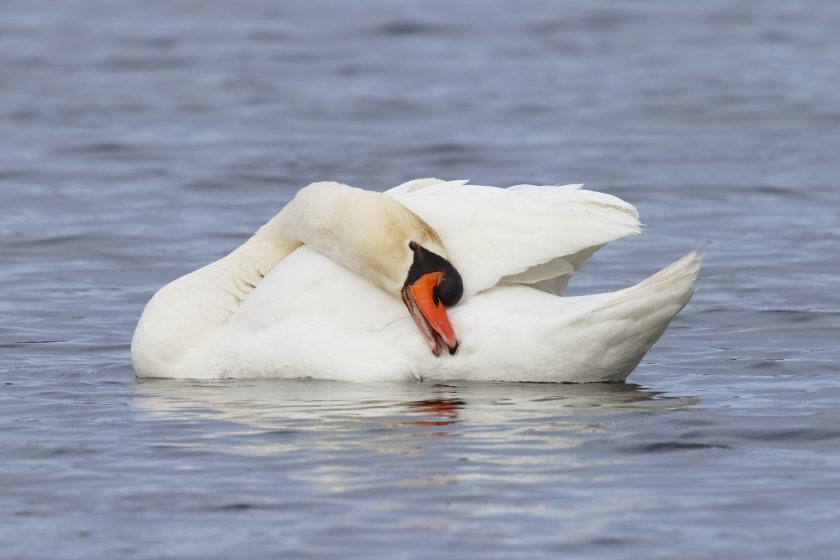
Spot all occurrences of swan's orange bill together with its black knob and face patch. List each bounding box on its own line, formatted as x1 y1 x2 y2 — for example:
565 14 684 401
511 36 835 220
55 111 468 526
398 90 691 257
400 241 464 356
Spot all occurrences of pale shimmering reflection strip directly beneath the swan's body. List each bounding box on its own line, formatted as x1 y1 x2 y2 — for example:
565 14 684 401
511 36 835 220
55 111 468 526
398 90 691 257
133 380 696 440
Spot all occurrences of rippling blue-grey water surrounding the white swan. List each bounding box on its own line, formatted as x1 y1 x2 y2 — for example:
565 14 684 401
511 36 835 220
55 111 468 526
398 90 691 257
0 0 840 559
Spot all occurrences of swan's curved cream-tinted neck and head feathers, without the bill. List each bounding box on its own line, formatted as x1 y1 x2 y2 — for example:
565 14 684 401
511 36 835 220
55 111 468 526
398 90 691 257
132 182 446 377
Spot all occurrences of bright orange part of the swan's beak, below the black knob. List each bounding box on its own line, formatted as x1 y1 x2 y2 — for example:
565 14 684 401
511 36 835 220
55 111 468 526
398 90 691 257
402 272 458 356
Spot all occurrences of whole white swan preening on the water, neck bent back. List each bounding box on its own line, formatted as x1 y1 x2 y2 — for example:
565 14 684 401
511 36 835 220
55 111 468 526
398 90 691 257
132 179 701 382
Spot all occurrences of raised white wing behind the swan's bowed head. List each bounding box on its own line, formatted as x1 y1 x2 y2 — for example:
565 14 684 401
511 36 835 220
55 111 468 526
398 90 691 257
387 179 640 297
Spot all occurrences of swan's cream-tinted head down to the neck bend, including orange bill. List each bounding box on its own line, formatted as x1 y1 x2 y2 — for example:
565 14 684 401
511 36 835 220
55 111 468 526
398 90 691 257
286 181 464 356
